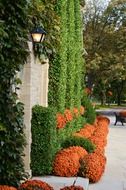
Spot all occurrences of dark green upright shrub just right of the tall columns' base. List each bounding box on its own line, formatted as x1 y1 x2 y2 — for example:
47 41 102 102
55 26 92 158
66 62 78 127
81 94 96 124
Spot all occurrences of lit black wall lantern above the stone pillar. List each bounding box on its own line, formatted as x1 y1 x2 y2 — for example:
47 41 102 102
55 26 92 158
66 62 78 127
31 28 46 43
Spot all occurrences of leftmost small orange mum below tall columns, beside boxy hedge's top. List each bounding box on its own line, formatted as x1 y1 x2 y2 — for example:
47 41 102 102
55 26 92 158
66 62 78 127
56 113 66 129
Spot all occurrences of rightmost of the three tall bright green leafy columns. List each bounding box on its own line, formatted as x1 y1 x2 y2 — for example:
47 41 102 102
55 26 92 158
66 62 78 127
74 0 84 107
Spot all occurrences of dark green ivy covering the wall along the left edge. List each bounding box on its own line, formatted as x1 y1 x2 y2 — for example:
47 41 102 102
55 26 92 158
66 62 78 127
0 0 28 186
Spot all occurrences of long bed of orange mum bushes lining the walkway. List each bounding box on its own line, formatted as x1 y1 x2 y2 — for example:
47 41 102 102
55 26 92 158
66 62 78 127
54 116 110 183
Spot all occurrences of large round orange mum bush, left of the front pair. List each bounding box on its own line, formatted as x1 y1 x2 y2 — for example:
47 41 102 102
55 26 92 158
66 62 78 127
53 146 88 177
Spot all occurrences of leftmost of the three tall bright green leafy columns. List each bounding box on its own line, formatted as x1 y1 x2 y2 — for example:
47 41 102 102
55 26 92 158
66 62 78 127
58 0 67 111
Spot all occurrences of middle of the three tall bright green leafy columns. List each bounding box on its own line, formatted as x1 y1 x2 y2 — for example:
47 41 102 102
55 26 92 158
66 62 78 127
66 0 75 108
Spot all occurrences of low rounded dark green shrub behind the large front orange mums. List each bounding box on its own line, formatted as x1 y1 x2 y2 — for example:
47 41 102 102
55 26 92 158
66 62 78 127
62 136 95 153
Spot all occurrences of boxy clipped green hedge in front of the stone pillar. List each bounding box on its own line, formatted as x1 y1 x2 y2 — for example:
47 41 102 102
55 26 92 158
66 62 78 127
31 105 59 175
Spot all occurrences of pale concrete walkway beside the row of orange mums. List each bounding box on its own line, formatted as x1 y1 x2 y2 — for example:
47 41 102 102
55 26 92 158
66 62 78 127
89 109 126 190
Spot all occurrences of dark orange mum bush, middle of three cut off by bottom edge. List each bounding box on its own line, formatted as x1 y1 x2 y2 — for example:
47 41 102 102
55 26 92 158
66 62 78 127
18 180 53 190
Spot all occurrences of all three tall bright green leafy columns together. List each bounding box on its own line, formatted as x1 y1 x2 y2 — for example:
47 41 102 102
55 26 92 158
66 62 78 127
54 0 84 111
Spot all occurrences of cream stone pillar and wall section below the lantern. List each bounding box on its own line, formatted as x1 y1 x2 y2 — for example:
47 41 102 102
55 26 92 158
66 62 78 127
19 42 49 175
